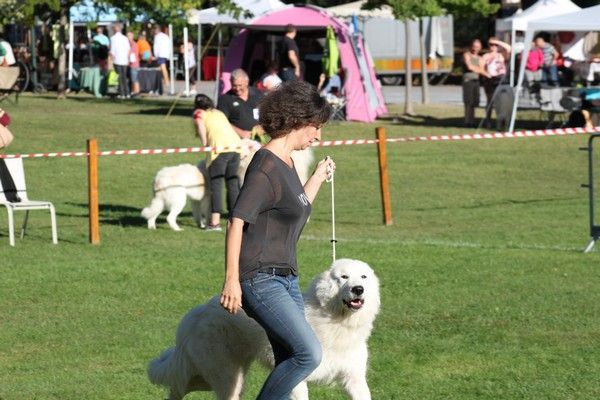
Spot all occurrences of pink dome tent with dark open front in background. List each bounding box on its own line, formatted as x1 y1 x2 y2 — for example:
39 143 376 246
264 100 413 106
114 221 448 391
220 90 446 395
221 5 387 122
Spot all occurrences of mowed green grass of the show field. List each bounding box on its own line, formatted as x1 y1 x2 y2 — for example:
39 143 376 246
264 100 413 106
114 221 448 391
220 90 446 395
0 96 600 400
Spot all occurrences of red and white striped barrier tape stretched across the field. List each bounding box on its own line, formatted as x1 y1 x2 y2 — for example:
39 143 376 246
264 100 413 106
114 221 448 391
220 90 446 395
0 126 600 158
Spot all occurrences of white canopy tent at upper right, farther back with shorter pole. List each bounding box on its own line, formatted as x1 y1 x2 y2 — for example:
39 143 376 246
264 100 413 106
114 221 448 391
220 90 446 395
496 0 581 86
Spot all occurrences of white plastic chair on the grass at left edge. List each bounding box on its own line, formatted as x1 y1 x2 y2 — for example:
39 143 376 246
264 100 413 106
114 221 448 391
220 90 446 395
0 158 58 246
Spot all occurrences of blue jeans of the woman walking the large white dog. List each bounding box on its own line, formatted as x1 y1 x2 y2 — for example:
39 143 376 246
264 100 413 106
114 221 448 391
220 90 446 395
241 272 321 400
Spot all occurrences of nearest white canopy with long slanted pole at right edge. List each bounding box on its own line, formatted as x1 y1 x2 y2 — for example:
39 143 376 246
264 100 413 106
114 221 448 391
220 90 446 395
509 5 600 132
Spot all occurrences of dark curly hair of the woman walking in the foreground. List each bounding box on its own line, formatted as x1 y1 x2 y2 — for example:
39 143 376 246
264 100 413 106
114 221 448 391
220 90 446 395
258 80 331 139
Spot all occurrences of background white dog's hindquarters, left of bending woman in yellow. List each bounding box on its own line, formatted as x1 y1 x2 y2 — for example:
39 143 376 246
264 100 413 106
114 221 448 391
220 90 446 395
142 164 210 231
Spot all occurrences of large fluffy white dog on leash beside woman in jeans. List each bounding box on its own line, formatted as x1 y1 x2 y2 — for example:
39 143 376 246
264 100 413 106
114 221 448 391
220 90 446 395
148 259 380 400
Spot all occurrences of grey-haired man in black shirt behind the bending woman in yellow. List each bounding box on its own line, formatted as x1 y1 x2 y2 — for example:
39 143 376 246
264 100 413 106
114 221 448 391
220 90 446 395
217 69 263 139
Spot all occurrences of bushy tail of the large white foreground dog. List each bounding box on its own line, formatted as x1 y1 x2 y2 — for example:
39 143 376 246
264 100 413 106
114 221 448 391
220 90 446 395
148 347 191 398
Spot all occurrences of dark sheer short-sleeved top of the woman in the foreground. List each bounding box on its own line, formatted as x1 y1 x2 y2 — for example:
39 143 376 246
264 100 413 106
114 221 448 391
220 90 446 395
231 148 311 280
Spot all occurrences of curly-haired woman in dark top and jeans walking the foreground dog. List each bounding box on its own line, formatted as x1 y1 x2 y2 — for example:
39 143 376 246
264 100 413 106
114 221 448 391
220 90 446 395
221 81 335 400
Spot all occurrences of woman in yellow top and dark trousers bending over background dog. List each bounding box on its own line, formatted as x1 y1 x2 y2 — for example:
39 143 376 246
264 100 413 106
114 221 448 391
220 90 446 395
193 94 242 231
